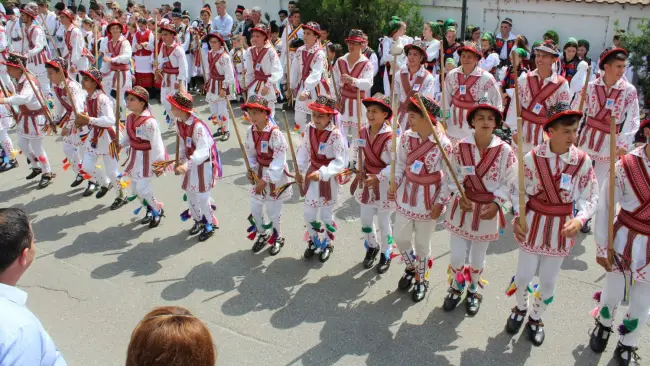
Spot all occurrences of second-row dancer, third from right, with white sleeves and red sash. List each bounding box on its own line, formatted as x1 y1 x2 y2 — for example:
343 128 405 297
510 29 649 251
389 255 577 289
444 44 503 145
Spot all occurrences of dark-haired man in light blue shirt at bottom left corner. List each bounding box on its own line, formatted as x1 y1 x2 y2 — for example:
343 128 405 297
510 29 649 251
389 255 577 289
0 208 66 366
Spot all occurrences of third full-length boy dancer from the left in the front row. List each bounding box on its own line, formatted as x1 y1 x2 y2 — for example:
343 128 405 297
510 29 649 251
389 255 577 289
76 68 126 206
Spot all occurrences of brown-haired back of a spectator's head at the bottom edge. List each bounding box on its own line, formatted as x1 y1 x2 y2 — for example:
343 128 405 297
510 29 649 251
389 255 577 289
126 306 217 366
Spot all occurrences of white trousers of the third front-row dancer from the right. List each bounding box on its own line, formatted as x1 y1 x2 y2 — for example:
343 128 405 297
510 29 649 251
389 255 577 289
449 234 490 292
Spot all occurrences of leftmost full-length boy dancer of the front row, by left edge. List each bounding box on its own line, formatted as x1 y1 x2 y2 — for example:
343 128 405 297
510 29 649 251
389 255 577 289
0 53 55 188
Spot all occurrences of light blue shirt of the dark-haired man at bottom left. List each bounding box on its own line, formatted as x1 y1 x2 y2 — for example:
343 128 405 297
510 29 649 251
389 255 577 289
0 283 67 366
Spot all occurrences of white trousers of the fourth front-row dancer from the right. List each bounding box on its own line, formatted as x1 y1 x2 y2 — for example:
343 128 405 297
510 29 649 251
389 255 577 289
394 214 436 281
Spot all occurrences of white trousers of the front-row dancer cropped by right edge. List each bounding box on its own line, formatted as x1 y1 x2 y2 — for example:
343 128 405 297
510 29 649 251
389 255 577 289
599 272 650 347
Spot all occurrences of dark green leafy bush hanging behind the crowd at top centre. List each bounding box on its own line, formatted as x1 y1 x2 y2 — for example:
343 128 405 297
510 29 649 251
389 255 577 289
298 0 424 50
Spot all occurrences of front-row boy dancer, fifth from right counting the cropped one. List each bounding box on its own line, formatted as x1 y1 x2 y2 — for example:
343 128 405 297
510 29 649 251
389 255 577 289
351 93 395 273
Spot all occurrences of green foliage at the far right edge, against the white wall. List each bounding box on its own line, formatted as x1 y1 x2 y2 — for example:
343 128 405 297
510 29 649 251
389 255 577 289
622 20 650 108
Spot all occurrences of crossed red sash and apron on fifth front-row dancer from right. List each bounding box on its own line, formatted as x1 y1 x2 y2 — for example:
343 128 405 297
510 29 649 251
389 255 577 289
350 127 393 204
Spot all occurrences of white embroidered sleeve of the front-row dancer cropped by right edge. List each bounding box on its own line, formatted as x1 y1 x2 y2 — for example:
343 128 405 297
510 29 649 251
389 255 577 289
593 160 629 257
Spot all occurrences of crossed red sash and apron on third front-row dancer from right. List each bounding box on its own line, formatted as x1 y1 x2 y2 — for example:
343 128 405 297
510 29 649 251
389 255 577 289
451 142 506 231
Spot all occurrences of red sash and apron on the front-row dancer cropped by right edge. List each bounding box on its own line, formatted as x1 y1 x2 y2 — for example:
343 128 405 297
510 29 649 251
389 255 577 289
610 154 650 264
